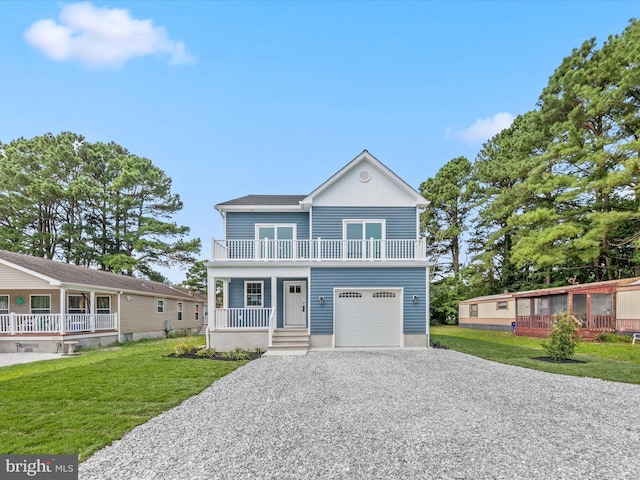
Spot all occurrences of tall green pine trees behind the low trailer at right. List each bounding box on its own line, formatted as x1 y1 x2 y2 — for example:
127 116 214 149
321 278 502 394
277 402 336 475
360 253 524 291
420 19 640 323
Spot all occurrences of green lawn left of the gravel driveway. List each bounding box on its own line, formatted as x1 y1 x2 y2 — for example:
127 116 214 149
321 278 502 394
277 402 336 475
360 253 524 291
0 337 247 460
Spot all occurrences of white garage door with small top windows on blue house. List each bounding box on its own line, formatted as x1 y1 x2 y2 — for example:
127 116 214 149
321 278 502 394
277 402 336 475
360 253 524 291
334 288 402 347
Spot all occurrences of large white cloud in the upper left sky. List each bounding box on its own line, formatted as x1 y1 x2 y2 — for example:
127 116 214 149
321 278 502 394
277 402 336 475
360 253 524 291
24 2 195 67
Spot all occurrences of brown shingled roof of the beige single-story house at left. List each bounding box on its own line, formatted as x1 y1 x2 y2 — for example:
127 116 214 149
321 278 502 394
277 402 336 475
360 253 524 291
0 250 206 301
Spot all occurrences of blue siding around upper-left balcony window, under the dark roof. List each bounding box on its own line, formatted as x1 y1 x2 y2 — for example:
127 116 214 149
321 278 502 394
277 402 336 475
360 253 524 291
226 212 309 240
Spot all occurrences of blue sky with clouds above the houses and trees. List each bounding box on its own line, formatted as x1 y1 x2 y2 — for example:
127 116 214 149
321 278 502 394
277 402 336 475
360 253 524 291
0 1 640 282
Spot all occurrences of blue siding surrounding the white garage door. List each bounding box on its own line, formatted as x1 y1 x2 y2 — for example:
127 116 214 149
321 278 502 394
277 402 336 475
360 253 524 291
309 268 427 335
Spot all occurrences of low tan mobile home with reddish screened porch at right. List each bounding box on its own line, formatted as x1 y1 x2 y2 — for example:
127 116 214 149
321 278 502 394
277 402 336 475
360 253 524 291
458 278 640 338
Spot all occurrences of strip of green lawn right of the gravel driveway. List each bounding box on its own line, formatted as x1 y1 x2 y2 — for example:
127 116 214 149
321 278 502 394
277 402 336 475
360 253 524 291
431 326 640 384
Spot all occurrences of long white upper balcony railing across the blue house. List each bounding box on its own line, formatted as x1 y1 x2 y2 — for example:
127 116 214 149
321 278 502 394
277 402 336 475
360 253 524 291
211 238 427 262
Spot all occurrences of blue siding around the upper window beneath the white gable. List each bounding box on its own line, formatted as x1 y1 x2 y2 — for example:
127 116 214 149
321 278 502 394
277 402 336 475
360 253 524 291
312 207 417 240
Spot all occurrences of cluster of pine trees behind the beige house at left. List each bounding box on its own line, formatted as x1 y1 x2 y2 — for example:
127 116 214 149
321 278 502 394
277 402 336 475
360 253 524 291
0 132 200 281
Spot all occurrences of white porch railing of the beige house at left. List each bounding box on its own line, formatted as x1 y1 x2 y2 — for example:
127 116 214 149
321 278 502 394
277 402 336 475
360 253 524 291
0 313 118 335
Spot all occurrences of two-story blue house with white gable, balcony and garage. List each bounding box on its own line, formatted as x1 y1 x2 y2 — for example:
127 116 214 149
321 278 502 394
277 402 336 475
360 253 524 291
207 150 432 352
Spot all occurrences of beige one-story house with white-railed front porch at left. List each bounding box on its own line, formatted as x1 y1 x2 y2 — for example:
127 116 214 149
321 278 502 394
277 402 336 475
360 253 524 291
0 250 207 352
